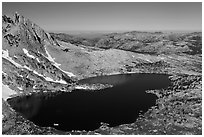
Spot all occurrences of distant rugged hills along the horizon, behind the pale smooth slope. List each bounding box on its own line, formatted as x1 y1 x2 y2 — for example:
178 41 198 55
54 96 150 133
51 31 202 55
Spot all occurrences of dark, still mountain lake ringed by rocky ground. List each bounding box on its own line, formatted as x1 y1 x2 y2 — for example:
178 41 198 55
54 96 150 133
7 74 170 131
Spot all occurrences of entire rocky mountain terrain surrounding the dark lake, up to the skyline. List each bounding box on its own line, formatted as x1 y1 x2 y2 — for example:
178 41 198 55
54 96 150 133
2 14 202 134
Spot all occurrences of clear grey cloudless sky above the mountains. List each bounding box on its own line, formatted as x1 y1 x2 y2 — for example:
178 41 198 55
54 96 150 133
2 2 202 31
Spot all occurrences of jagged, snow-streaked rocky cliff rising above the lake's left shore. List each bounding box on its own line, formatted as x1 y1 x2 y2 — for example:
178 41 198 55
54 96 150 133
2 14 74 98
